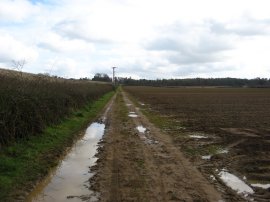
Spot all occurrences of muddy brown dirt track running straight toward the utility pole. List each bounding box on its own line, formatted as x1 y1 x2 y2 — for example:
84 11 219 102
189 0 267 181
91 92 222 201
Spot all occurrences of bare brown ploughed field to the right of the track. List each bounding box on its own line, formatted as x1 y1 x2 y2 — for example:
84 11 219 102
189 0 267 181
124 87 270 201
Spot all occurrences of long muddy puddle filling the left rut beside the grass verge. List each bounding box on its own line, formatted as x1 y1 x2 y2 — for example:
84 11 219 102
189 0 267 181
26 123 105 202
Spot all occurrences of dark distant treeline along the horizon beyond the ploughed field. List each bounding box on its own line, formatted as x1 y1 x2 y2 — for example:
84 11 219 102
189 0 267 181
117 78 270 87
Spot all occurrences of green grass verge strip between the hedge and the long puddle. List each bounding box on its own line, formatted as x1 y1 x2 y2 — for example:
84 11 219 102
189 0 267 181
0 92 114 201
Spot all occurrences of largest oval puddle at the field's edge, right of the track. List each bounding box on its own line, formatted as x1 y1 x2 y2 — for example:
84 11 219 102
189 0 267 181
218 170 254 196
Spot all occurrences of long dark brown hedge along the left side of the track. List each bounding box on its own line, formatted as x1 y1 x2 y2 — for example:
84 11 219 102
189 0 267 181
0 71 113 145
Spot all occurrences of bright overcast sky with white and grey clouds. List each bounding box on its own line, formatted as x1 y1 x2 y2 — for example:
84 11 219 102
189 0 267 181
0 0 270 79
